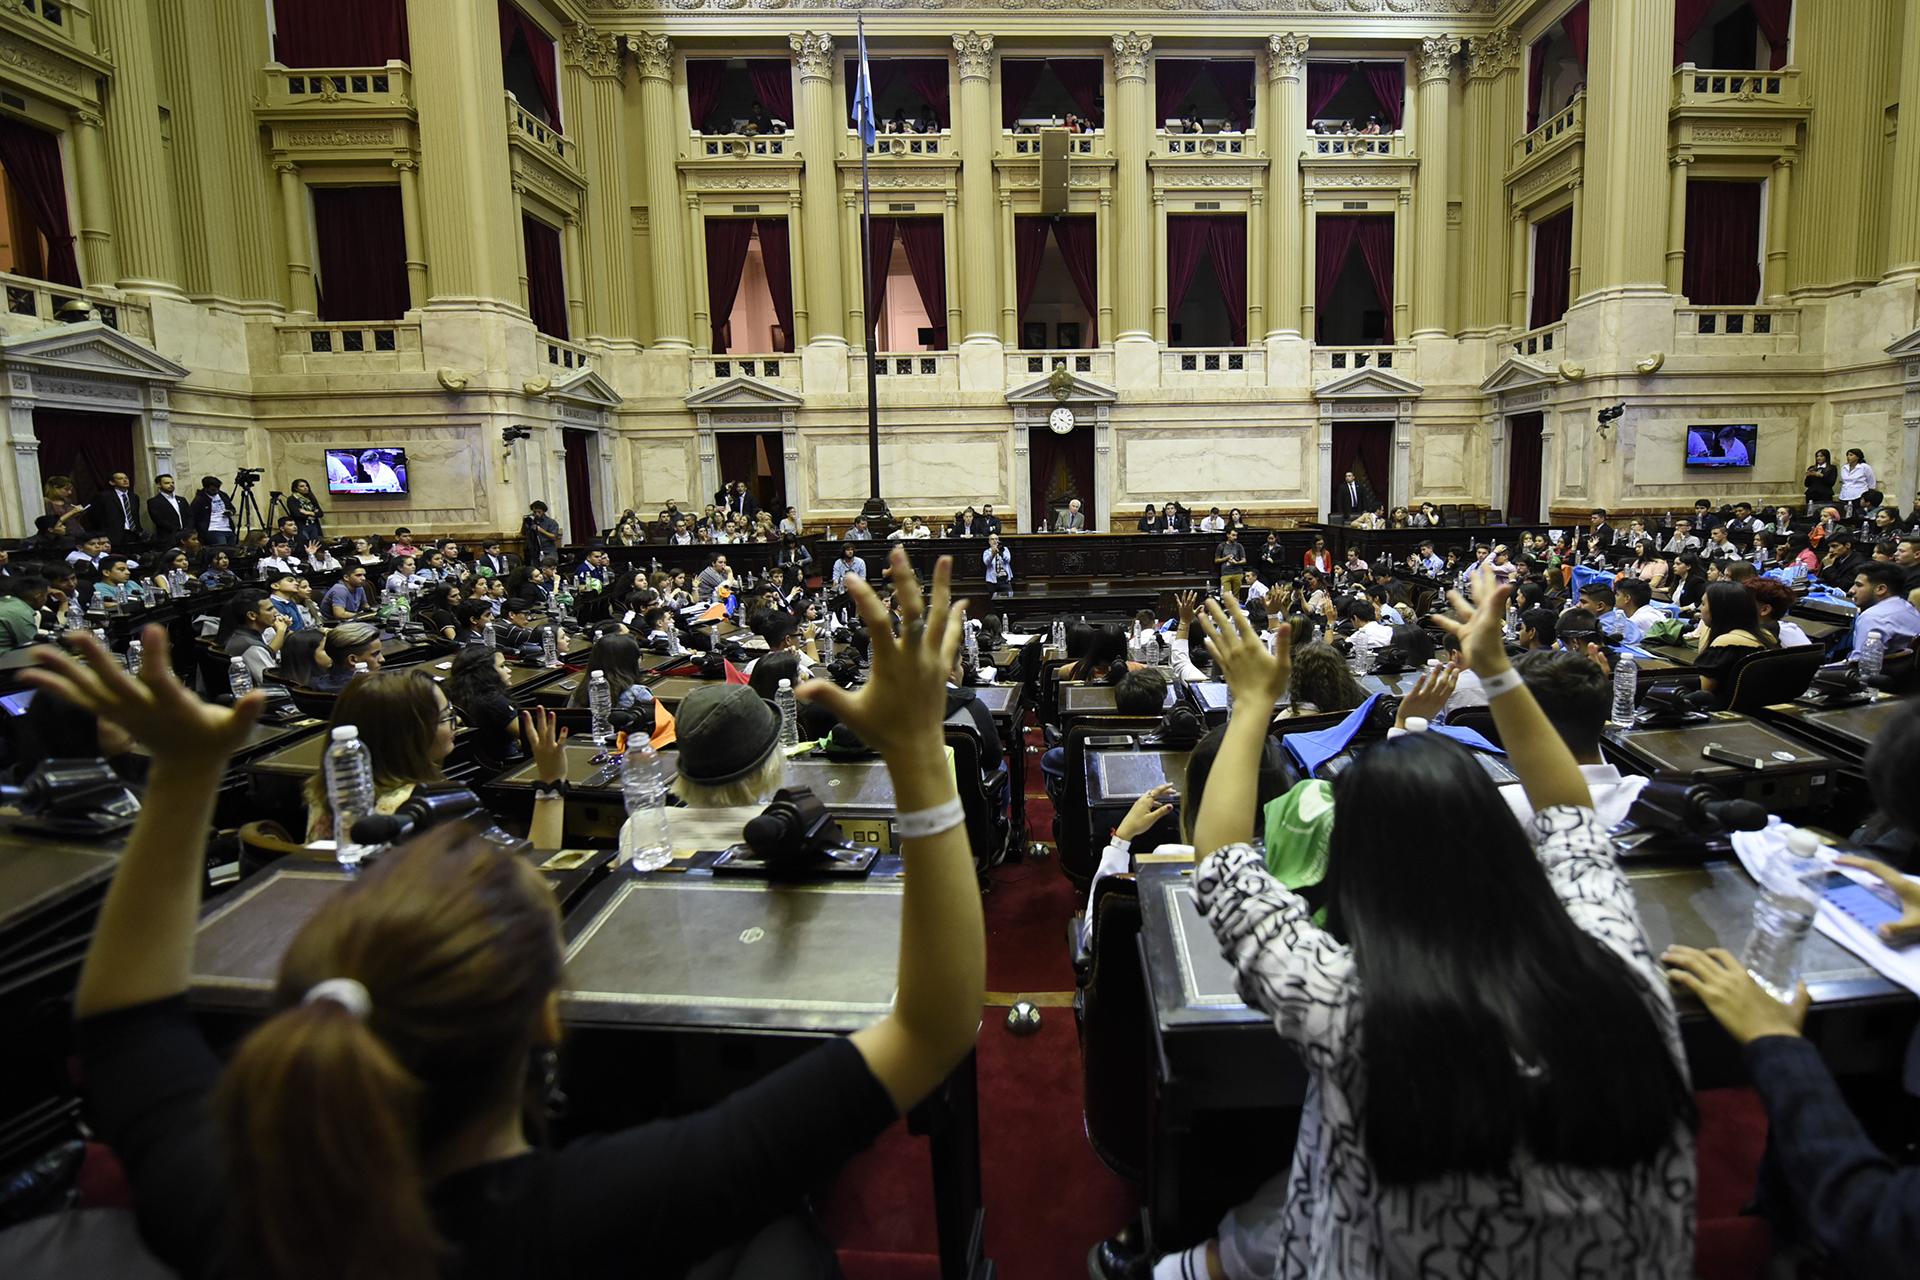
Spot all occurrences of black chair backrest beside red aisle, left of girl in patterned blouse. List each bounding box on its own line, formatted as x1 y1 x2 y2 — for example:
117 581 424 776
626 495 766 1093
1081 875 1154 1180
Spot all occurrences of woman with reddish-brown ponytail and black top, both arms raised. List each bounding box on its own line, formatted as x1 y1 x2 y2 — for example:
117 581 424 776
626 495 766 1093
27 549 985 1280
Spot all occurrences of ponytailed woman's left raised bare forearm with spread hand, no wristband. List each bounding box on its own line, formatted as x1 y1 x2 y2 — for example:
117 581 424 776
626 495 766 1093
21 626 267 1017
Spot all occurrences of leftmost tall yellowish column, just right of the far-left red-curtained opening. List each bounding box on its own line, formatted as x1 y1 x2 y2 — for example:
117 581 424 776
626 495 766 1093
94 0 184 297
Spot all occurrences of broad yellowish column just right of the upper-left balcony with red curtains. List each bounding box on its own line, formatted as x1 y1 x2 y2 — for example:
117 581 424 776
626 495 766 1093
407 0 522 307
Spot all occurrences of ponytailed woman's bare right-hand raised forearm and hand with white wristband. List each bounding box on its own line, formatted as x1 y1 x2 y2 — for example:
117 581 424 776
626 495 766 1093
797 547 987 1111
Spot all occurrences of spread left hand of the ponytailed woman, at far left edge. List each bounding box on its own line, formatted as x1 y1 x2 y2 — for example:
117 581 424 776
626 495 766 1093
19 626 267 768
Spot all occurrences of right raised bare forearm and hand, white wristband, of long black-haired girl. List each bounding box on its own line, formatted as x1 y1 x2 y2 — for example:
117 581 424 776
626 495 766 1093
1436 566 1594 810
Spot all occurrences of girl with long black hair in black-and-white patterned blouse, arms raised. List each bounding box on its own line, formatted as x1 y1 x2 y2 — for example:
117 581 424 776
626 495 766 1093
1167 568 1695 1280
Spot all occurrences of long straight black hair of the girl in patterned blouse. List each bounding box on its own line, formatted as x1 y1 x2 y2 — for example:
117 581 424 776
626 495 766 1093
1327 733 1693 1186
